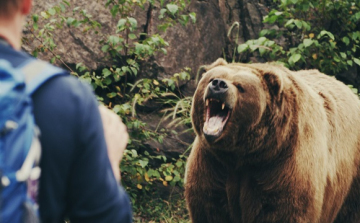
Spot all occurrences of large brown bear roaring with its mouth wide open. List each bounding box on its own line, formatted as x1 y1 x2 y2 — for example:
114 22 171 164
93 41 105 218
185 59 360 223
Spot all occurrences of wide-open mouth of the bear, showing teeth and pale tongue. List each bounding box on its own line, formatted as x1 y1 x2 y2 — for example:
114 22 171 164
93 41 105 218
203 98 231 138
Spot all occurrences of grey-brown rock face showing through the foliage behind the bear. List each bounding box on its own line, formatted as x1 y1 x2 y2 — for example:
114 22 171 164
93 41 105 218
23 0 266 156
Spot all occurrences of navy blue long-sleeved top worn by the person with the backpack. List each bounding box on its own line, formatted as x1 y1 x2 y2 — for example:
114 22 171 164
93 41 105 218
0 43 132 223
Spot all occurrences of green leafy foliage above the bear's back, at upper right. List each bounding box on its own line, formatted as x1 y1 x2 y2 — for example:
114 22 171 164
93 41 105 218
232 0 360 75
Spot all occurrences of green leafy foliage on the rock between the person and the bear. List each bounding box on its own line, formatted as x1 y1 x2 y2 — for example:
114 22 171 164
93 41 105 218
23 0 196 222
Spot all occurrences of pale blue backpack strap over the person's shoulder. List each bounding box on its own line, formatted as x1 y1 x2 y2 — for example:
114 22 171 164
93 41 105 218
21 60 67 95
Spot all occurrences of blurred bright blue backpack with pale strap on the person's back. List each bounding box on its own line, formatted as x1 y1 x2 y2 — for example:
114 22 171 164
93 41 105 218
0 59 64 223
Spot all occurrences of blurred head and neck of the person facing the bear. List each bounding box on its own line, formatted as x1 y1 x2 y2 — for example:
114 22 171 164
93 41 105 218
0 0 32 49
